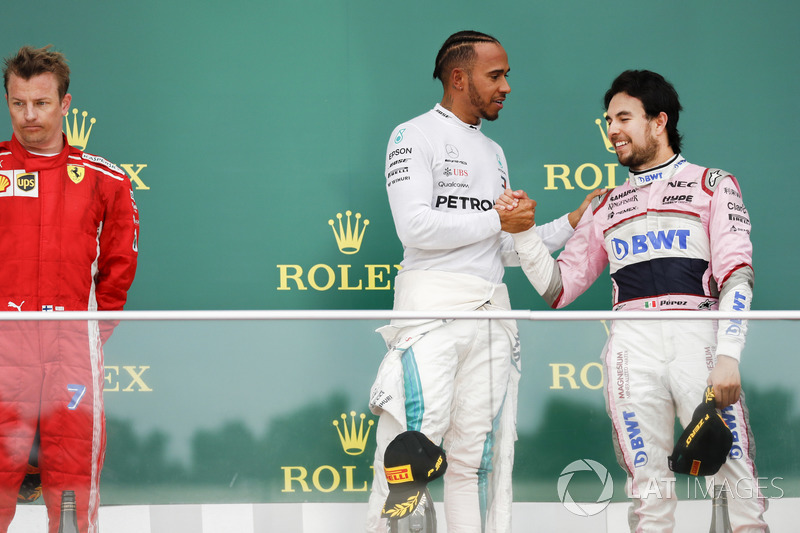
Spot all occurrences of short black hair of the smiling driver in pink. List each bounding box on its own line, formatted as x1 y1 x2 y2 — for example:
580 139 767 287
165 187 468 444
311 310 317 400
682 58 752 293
604 70 683 154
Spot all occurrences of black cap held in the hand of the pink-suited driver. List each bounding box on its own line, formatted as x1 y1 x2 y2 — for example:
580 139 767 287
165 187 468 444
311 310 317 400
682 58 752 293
667 385 733 476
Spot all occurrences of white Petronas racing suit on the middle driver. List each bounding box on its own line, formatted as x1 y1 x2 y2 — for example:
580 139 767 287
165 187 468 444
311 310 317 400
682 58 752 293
367 105 572 532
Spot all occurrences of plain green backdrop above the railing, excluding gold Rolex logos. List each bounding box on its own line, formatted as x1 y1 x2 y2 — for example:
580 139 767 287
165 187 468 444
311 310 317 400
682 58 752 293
0 0 800 309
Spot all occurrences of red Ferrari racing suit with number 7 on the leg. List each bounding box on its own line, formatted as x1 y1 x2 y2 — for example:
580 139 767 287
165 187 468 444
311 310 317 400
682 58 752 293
0 137 139 533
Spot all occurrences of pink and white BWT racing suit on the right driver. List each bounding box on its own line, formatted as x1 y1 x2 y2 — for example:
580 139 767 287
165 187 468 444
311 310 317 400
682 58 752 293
515 155 766 531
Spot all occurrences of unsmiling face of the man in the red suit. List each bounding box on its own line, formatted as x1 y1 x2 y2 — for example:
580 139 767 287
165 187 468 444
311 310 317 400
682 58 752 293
6 72 72 154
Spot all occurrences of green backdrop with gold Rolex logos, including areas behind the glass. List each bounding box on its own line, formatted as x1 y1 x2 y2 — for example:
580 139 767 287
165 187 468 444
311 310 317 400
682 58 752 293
0 0 800 503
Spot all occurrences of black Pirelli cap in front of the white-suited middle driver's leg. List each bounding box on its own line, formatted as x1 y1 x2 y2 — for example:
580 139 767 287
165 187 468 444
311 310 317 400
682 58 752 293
381 431 447 518
